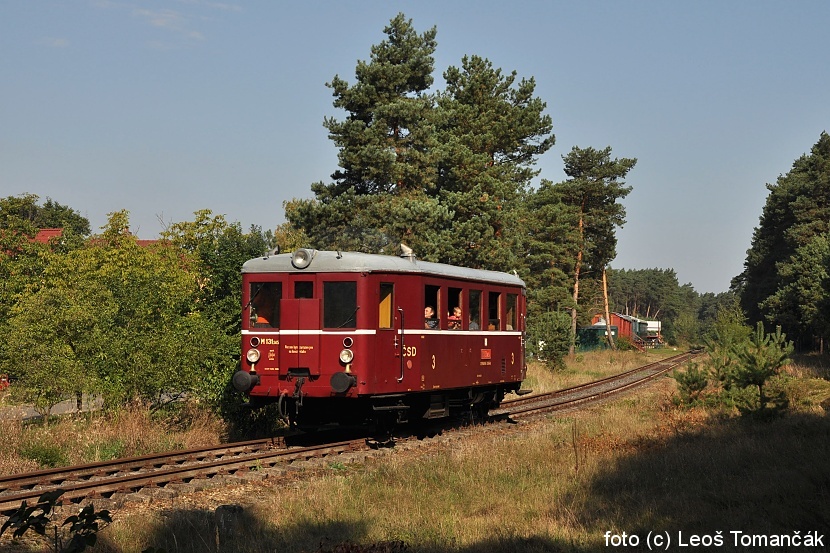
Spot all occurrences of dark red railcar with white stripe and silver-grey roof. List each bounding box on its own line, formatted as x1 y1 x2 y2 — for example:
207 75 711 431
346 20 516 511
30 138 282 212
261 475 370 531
233 249 526 425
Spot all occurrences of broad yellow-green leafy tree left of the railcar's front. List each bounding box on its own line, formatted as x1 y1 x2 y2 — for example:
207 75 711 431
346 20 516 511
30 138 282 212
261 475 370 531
3 211 228 405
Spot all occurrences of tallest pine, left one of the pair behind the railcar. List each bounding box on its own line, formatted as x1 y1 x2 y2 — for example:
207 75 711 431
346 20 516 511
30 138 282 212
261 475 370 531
285 14 451 253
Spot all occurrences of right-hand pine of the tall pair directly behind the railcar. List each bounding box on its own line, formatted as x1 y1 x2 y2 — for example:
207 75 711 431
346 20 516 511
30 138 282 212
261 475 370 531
436 56 555 269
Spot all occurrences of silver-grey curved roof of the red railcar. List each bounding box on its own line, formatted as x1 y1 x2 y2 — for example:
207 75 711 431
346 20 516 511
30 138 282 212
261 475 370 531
242 250 525 287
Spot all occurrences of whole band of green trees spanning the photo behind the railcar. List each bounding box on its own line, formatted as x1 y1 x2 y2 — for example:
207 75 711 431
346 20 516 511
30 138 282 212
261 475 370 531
0 14 830 416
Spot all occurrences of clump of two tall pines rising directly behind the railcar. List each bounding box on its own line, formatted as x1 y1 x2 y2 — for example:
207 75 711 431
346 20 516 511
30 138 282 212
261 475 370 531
285 14 554 270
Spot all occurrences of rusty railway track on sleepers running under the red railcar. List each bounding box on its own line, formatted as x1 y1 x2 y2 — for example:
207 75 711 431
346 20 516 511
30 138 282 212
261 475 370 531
0 353 694 516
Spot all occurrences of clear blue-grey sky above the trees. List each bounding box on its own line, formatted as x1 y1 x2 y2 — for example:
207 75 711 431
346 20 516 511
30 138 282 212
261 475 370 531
0 0 830 292
